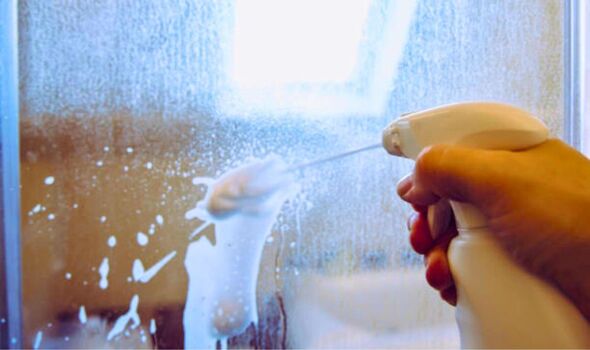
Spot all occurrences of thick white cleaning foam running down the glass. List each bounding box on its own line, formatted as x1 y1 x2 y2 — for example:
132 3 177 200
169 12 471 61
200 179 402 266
183 156 297 349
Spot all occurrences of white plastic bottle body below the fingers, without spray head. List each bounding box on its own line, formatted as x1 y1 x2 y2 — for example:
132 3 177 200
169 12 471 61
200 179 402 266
448 227 590 348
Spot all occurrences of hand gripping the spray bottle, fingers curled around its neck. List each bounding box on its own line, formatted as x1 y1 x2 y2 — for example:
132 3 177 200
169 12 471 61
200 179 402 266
398 140 590 320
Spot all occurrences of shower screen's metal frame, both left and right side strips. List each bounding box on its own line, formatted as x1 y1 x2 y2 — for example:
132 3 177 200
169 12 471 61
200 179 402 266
0 0 590 348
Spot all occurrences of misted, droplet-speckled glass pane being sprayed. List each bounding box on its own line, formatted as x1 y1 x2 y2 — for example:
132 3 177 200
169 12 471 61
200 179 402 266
19 0 563 348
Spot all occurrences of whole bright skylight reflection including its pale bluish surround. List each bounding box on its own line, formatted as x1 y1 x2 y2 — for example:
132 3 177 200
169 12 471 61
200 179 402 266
224 0 416 118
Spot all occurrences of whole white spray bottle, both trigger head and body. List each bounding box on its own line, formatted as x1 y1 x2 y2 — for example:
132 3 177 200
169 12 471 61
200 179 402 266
383 103 590 348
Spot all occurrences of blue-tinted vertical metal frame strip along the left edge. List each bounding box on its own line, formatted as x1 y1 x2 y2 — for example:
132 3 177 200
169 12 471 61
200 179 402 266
0 0 22 348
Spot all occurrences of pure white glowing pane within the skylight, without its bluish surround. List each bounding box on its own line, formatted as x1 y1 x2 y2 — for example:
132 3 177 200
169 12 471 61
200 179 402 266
230 0 370 87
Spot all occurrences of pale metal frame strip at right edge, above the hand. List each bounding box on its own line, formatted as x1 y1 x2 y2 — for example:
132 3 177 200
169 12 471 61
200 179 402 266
563 0 585 150
